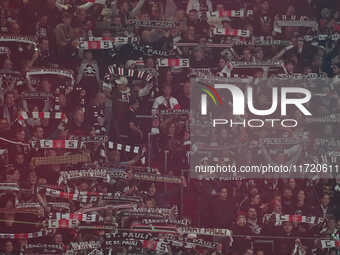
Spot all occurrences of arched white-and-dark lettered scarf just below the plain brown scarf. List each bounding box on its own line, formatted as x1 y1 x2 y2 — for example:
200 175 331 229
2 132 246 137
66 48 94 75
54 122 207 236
58 168 110 185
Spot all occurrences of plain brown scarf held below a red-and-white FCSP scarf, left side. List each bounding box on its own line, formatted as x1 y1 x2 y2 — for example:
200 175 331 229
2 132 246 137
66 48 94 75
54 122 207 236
31 153 91 167
